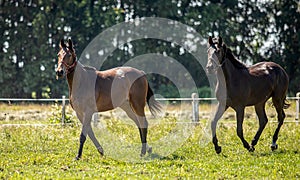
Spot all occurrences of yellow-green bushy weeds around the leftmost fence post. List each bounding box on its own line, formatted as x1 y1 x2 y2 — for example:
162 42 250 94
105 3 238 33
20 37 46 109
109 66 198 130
48 103 77 124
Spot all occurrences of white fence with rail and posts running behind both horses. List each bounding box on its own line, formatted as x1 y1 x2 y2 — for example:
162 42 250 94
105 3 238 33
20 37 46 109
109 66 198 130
0 92 300 123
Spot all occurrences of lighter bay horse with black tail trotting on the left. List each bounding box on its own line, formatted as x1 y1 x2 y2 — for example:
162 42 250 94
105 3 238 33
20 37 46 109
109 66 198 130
56 39 161 160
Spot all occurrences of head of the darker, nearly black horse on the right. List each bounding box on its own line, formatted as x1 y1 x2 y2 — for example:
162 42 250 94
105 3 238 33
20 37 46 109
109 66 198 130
206 36 226 74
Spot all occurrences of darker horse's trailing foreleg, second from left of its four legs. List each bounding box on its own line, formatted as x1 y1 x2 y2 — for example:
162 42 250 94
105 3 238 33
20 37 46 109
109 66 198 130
236 107 254 151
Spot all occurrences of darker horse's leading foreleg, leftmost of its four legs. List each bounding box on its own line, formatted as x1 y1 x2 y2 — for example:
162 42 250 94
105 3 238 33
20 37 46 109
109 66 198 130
211 103 227 154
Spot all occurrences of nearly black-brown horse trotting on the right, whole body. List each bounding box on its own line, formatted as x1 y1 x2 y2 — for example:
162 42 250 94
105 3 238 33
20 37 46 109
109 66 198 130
206 36 289 154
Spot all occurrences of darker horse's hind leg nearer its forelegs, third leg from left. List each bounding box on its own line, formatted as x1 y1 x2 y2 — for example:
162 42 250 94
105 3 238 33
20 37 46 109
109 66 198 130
251 102 268 150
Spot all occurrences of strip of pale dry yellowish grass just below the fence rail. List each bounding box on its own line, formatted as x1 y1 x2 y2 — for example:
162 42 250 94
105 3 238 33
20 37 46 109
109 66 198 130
0 104 295 121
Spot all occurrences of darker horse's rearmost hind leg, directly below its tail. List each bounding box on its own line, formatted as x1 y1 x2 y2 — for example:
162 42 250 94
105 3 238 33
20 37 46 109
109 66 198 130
271 97 285 151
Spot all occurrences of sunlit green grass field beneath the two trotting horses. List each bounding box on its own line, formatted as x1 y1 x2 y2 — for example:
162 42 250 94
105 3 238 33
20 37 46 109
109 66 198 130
0 102 300 179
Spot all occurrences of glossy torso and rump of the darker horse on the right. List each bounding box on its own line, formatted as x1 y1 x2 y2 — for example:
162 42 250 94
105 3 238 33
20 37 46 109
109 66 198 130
227 62 288 106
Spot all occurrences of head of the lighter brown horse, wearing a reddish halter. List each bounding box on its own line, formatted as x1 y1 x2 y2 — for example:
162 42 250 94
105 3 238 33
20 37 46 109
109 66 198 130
56 39 77 79
